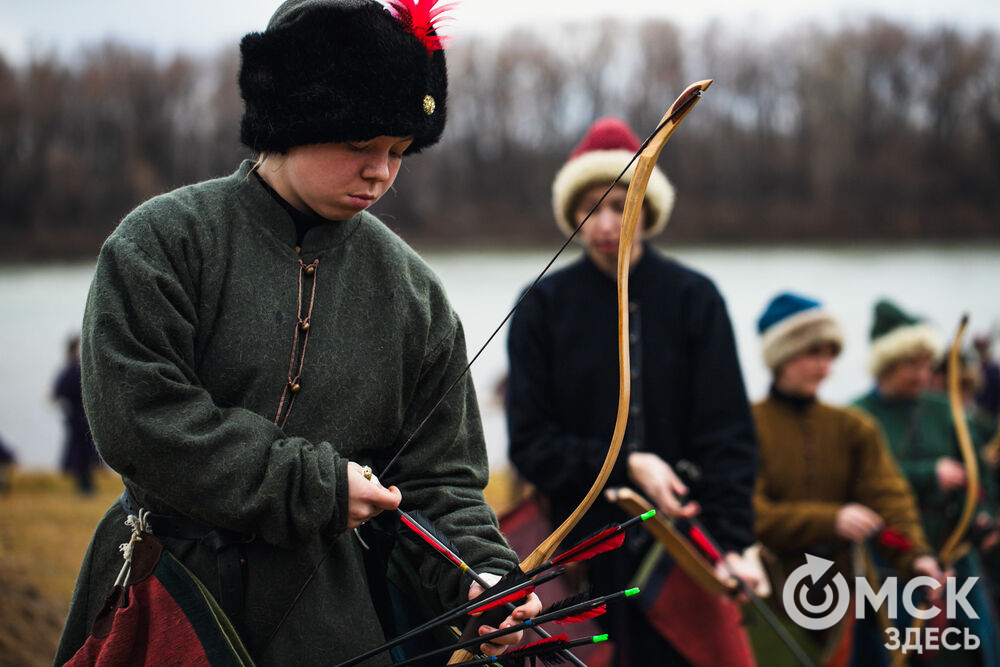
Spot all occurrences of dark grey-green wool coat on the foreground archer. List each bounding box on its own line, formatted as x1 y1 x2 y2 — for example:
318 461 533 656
57 162 517 665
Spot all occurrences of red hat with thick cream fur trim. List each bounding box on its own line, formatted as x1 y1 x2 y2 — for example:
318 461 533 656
552 118 674 236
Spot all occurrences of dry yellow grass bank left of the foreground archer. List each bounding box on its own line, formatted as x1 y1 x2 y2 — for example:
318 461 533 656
0 471 122 667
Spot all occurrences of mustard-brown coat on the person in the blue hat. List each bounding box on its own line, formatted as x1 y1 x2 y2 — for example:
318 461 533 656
753 396 930 578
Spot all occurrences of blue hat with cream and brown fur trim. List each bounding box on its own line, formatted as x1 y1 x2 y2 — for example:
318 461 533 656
757 292 844 372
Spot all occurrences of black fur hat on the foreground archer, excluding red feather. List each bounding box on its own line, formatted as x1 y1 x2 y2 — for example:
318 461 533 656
240 0 448 153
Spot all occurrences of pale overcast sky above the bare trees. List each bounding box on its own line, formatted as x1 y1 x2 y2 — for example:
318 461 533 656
0 0 1000 62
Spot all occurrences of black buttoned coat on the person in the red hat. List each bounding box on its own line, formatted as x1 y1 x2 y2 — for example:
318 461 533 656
508 244 757 551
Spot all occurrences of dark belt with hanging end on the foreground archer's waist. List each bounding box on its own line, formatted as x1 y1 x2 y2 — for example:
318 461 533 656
118 487 254 631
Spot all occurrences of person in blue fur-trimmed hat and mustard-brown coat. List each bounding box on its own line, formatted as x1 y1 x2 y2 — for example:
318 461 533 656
753 293 943 665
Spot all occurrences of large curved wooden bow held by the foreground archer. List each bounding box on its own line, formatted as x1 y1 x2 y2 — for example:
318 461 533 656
448 79 712 665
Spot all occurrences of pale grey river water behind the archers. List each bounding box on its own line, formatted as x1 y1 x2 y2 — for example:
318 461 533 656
0 243 1000 468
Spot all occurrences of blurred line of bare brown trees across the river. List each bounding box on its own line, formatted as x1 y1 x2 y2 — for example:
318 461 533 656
0 19 1000 259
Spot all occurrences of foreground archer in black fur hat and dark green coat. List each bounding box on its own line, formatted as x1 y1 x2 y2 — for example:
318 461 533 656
56 0 541 665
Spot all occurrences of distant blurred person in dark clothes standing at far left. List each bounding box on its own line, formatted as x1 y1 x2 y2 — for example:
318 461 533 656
52 336 101 495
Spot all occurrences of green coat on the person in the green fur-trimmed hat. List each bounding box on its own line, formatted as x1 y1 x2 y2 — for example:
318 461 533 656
854 391 995 550
